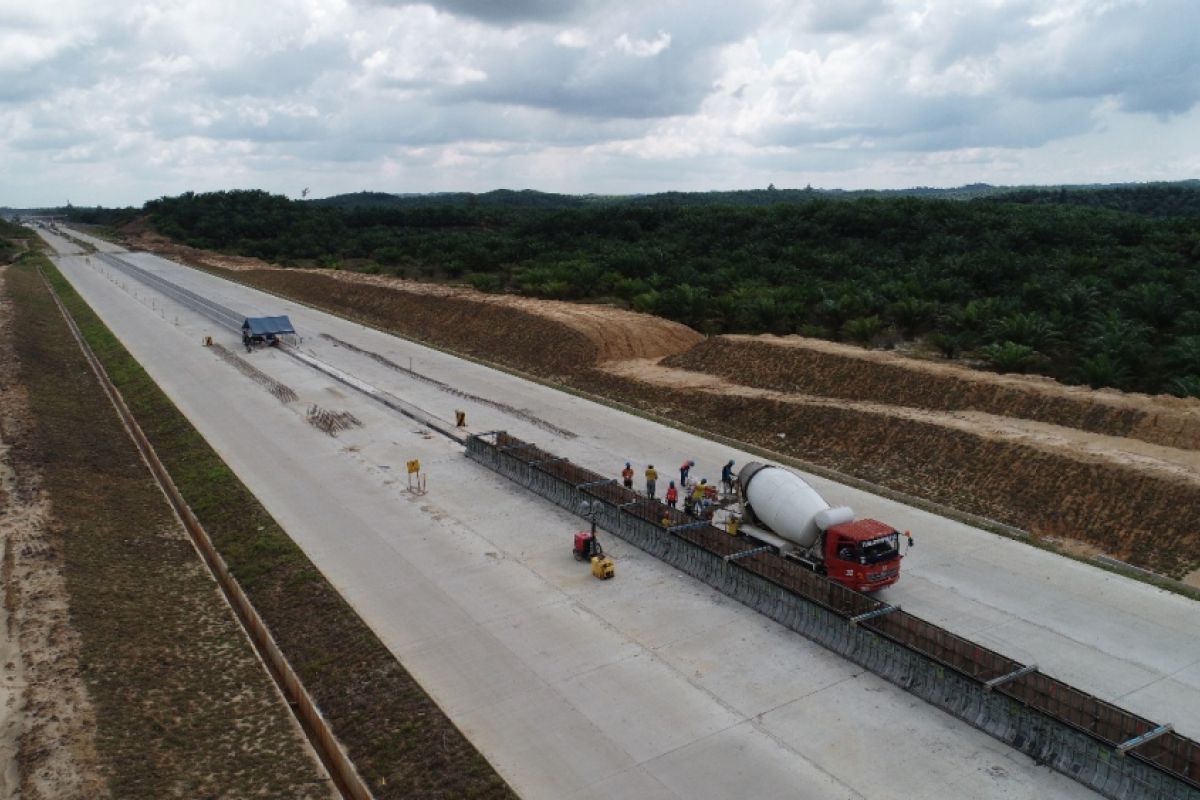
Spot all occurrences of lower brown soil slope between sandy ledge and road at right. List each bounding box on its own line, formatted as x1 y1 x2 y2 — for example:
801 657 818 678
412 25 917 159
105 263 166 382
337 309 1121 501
576 366 1200 576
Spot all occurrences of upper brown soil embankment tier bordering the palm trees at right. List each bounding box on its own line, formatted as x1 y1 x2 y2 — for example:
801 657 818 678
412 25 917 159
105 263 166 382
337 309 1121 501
664 336 1200 450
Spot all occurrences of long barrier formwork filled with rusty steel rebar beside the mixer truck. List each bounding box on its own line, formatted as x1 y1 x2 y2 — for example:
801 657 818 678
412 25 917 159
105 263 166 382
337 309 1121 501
467 432 1200 800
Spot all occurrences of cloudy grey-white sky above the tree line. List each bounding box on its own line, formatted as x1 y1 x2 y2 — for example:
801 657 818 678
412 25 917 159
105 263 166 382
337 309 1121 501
0 0 1200 206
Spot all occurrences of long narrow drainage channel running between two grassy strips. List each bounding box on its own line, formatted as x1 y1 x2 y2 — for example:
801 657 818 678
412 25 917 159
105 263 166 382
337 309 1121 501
37 267 374 800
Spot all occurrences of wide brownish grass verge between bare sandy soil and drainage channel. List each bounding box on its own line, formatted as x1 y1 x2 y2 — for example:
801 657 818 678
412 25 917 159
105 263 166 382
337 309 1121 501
5 254 328 799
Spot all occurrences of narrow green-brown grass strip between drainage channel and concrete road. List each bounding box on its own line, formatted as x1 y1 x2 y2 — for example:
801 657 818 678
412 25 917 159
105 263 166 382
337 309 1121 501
36 253 514 800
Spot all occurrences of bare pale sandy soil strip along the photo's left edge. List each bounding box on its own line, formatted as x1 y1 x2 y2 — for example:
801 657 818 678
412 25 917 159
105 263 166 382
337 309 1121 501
0 266 107 800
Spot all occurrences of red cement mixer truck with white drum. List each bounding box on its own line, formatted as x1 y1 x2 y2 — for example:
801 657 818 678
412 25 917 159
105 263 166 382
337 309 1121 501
738 462 912 591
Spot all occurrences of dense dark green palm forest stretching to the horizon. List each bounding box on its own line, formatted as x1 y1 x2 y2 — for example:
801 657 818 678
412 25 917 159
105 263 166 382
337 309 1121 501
68 182 1200 396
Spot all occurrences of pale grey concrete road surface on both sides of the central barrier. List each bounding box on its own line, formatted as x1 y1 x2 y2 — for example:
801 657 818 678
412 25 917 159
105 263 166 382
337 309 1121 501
37 226 1200 798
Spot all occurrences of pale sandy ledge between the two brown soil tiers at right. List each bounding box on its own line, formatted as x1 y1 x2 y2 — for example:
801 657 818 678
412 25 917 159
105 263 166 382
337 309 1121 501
604 359 1200 483
